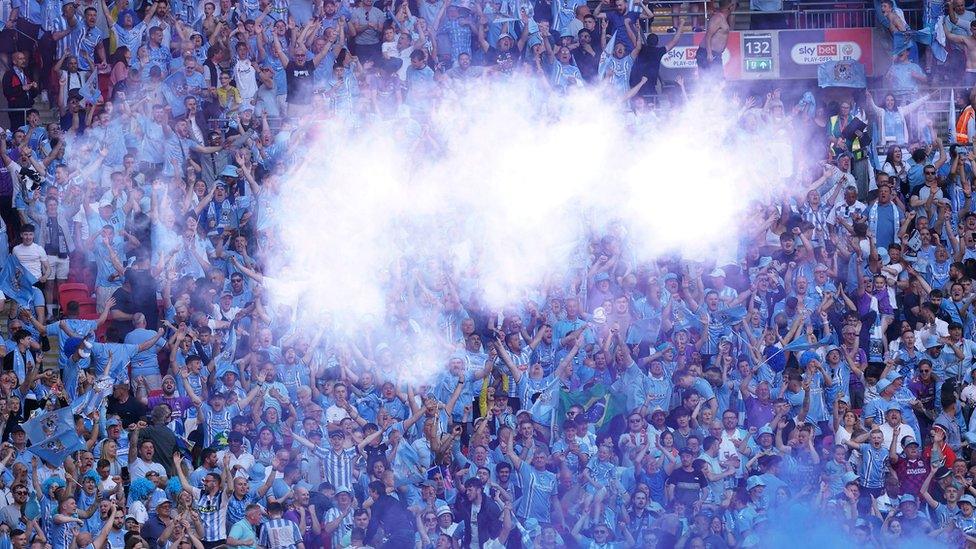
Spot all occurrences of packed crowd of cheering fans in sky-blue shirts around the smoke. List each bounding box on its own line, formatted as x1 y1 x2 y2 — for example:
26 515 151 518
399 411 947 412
0 0 976 549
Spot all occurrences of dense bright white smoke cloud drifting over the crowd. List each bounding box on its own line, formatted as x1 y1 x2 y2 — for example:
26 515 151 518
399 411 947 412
270 76 800 382
